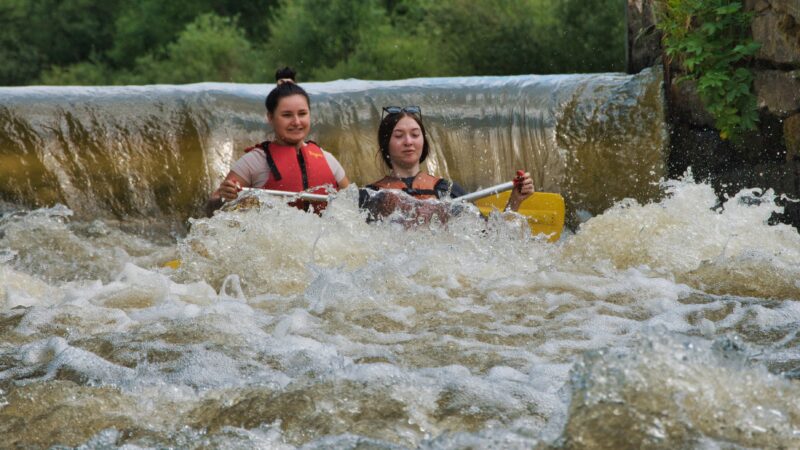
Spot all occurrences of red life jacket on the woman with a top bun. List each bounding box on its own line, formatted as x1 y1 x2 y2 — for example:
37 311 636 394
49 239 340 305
245 141 339 214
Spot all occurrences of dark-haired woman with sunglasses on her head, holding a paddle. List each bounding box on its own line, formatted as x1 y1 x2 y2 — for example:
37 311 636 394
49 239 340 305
360 106 534 223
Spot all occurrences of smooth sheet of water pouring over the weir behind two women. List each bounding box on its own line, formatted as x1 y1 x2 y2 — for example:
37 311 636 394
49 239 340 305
0 71 666 230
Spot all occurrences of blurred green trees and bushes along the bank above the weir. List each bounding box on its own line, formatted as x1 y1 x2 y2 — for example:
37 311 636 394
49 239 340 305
0 0 625 86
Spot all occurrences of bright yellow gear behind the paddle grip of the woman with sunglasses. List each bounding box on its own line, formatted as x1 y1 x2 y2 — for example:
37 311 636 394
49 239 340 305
475 192 565 242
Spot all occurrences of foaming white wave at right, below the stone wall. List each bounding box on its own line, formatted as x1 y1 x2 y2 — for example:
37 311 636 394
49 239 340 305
563 177 800 298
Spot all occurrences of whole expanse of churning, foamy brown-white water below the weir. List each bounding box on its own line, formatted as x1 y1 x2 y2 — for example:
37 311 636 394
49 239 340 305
0 180 800 449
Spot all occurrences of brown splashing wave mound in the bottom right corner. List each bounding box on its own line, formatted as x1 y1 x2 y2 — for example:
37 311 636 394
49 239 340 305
565 331 800 448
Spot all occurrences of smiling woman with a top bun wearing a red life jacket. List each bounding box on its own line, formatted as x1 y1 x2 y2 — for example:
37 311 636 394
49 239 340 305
206 67 350 216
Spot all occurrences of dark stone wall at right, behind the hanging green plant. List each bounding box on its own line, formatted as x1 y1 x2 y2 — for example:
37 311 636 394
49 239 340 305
627 0 800 225
